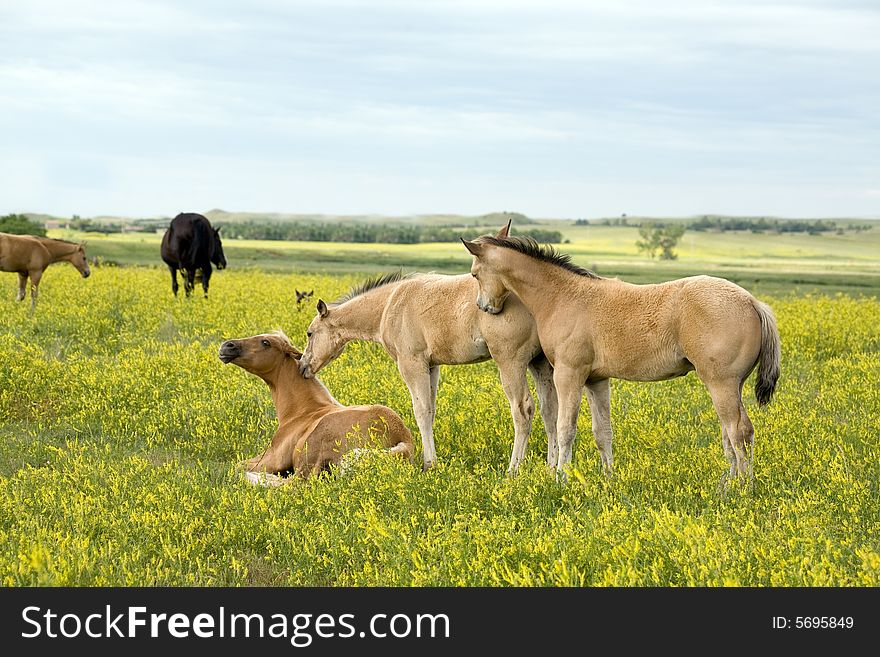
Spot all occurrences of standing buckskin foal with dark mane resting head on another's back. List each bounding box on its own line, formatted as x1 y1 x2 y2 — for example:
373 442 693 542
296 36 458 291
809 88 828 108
462 237 780 478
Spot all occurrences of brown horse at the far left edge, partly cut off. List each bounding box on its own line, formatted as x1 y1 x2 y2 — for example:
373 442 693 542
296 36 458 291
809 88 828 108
0 233 92 310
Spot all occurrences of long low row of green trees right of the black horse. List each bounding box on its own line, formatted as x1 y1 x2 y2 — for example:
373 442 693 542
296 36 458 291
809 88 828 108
217 221 562 244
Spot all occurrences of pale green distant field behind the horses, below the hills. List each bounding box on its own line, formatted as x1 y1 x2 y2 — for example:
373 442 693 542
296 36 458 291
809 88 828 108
50 223 880 296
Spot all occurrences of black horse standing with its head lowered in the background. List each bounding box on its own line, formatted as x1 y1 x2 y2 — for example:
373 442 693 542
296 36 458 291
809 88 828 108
162 212 226 299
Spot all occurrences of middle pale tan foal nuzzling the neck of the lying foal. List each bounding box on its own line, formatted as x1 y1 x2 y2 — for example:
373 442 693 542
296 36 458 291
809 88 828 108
300 224 557 474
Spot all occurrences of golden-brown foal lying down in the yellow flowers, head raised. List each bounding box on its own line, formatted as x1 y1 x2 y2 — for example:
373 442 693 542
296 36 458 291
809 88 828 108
219 332 413 481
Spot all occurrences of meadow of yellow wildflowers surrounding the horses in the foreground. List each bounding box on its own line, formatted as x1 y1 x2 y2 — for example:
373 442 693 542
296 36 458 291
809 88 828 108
0 266 880 586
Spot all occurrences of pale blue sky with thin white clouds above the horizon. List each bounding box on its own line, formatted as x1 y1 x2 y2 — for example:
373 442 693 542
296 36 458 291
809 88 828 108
0 0 880 218
